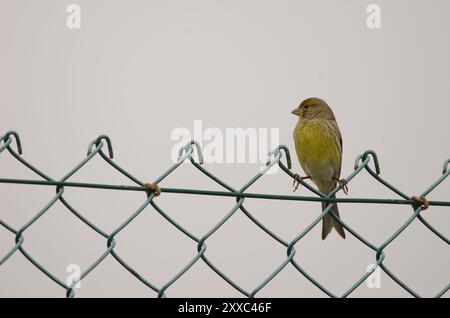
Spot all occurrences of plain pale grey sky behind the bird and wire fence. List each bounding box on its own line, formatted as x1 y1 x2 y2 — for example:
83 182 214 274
0 0 450 297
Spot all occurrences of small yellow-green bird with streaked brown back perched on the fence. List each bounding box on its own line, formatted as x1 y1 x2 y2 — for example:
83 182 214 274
291 97 348 240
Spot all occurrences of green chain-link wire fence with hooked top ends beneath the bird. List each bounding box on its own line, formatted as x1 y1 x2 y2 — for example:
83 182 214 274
0 131 450 297
